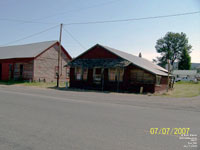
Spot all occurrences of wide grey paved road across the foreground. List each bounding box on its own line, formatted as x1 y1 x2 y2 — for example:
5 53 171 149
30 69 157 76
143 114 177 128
0 86 200 150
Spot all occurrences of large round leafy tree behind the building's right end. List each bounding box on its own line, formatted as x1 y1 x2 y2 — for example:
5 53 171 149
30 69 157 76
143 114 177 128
155 32 192 69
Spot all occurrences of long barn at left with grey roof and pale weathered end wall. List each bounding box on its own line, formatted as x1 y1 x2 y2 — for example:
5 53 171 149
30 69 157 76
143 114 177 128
0 41 72 82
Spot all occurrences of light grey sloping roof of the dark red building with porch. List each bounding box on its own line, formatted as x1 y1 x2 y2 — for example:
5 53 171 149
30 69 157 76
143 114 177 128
100 45 168 76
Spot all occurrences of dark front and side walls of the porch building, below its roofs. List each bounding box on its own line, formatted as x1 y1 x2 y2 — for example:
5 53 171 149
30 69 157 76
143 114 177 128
70 65 158 93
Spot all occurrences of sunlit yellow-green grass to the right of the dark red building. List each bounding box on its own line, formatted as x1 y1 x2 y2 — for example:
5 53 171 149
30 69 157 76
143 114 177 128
162 82 200 97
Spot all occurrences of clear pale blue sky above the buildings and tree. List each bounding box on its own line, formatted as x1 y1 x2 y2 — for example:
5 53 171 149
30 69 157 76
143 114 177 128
0 0 200 63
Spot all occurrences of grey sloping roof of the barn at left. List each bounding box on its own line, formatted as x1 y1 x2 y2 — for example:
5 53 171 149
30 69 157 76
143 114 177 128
0 41 57 59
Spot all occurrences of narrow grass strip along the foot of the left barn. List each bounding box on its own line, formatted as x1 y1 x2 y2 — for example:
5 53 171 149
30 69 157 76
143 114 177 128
0 81 65 88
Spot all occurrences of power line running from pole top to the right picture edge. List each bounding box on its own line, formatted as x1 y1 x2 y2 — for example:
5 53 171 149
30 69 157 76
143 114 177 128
64 11 200 25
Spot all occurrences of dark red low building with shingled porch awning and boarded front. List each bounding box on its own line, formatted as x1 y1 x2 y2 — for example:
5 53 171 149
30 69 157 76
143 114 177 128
68 44 168 93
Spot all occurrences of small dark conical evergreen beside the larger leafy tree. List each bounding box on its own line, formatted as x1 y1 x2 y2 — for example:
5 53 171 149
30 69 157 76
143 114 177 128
178 49 191 70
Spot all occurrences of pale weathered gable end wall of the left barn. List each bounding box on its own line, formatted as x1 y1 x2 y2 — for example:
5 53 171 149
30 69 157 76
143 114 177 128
33 45 70 82
